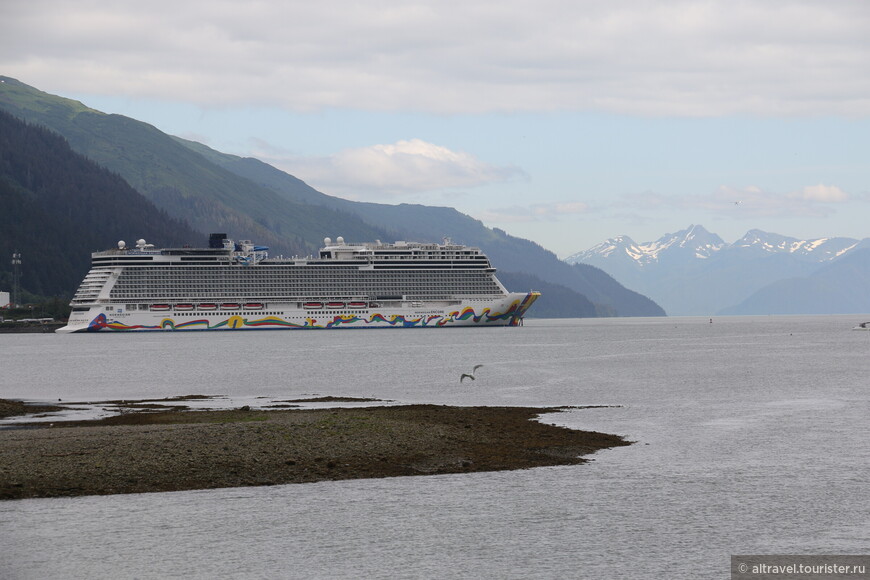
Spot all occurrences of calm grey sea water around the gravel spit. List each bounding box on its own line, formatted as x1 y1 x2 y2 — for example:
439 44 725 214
0 317 870 579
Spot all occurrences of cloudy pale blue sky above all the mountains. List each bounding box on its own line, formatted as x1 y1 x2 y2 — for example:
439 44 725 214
0 0 870 257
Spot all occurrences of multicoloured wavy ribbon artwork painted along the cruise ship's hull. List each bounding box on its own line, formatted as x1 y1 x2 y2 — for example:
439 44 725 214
81 292 540 332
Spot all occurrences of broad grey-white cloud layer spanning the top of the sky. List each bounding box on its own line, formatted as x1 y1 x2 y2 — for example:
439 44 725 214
0 0 870 116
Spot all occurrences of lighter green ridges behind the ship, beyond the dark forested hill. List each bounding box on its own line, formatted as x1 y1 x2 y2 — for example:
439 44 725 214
0 77 664 316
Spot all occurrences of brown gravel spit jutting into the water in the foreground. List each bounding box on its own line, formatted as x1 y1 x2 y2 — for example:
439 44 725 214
0 400 630 500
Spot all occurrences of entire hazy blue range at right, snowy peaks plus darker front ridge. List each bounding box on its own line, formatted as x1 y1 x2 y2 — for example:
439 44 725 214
565 225 870 316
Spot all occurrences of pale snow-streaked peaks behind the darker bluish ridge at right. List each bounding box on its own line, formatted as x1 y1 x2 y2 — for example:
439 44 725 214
565 225 870 315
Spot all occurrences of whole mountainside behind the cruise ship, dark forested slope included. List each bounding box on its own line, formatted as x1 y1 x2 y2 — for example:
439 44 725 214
0 76 664 317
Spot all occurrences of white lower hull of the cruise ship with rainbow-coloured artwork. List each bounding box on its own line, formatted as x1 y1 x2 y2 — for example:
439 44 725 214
57 292 539 333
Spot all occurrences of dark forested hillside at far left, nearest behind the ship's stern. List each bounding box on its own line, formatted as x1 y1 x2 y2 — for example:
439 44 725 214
0 111 205 299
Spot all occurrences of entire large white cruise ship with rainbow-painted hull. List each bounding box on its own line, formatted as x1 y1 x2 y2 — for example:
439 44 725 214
57 234 540 332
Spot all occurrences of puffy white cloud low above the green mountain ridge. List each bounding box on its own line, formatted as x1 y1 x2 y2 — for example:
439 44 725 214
262 139 525 200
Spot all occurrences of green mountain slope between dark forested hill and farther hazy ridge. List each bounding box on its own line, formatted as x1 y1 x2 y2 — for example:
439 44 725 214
0 77 385 255
